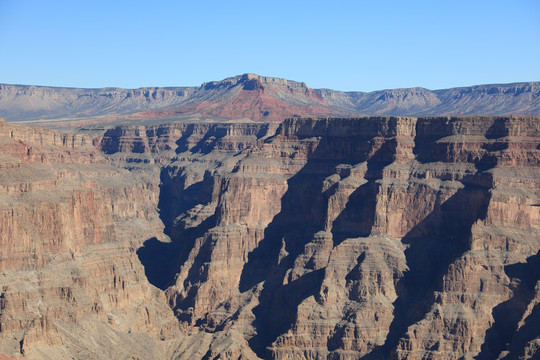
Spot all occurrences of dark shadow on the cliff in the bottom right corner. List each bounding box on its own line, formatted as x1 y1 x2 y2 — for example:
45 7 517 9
476 251 540 360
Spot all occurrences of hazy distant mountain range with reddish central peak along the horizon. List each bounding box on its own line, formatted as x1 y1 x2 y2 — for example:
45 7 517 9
0 74 540 125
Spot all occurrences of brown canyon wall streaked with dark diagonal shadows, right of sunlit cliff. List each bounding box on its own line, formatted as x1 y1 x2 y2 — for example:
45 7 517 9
102 117 540 359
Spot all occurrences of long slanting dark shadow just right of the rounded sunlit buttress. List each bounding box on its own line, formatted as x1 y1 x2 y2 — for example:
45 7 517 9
366 179 490 359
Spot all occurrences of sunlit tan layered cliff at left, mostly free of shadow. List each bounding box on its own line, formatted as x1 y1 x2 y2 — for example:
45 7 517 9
0 117 178 359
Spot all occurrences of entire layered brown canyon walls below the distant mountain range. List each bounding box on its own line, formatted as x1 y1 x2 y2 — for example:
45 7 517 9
0 116 540 359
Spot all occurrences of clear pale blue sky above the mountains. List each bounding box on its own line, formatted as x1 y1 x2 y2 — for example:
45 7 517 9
0 0 540 91
